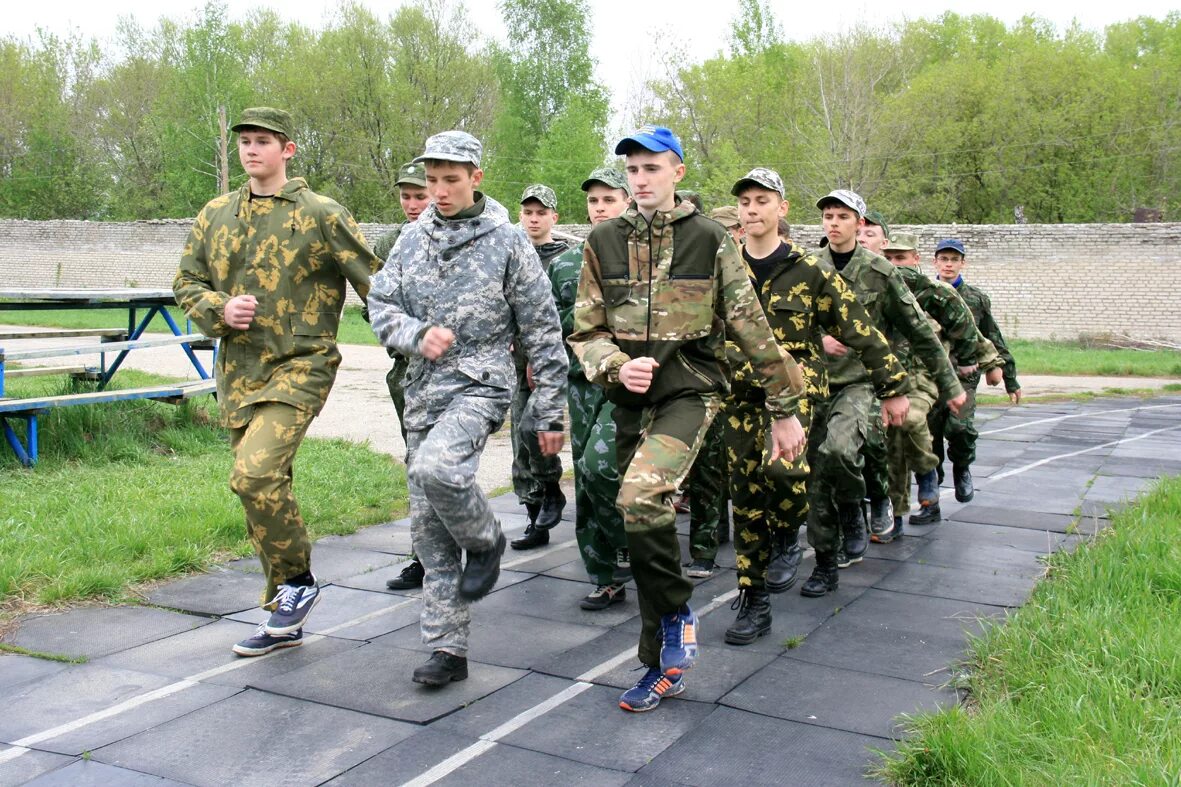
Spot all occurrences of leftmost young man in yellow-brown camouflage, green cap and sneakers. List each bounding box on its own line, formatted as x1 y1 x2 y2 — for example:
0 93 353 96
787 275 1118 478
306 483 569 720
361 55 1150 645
172 106 380 656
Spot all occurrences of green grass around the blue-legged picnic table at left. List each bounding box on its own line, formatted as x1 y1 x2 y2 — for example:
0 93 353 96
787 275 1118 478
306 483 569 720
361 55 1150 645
0 370 406 609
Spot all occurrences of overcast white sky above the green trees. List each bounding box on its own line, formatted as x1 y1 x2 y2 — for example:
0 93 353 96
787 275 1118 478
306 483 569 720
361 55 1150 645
0 0 1179 128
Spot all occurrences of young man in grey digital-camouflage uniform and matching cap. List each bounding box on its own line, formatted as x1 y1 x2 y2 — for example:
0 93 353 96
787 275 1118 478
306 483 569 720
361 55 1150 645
368 131 567 685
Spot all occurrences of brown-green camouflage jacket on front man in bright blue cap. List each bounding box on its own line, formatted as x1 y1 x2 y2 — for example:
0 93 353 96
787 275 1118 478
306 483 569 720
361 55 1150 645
568 201 803 417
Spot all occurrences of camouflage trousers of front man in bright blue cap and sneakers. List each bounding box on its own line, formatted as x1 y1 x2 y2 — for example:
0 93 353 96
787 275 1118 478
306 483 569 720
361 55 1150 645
615 394 720 666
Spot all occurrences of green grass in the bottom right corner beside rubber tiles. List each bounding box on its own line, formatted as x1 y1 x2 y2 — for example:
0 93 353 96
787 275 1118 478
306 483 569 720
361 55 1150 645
877 479 1181 787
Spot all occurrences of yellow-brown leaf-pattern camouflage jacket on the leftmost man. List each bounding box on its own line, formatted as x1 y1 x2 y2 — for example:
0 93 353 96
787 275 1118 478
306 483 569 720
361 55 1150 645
172 177 380 425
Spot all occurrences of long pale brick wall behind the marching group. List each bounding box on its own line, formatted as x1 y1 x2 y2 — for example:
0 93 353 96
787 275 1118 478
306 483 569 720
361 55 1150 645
0 221 1181 342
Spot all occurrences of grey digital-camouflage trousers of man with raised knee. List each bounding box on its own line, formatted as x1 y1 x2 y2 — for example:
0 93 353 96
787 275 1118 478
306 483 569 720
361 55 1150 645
406 396 501 656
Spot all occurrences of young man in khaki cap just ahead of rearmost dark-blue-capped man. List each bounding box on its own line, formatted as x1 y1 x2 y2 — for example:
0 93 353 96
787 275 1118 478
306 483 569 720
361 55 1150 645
869 233 1001 534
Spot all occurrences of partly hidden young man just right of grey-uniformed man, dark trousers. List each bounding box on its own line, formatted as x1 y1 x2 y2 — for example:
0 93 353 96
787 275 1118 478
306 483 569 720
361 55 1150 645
510 183 570 549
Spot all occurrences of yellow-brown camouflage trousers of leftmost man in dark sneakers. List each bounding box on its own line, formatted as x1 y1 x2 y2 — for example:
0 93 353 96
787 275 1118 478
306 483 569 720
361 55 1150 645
229 402 315 604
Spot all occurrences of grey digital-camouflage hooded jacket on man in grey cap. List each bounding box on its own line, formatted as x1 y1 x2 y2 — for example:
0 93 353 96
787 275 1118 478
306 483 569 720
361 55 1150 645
368 197 567 431
